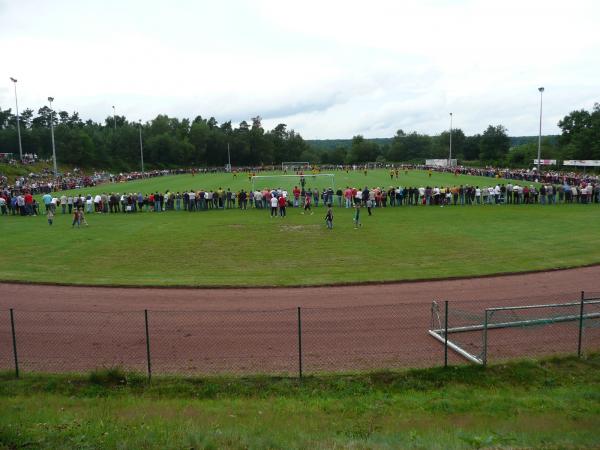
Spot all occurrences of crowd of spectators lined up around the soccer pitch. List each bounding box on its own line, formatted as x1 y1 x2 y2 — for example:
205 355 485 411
0 164 600 219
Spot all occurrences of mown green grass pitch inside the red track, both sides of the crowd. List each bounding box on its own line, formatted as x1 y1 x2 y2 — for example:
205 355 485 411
0 171 600 286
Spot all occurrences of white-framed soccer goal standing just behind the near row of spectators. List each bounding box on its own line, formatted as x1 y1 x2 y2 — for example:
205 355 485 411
251 173 337 206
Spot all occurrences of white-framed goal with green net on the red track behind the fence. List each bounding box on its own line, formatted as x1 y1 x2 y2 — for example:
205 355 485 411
429 298 600 365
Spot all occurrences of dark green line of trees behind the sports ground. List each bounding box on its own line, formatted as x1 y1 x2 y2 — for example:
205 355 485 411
0 104 600 170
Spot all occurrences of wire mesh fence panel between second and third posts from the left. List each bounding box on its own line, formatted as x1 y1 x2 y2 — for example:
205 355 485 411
148 309 298 375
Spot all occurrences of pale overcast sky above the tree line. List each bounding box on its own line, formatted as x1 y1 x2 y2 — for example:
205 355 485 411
0 0 600 139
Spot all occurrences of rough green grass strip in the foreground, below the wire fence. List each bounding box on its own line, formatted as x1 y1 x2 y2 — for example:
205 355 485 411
0 355 600 448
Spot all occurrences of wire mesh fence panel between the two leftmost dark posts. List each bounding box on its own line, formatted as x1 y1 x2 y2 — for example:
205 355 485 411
14 311 146 372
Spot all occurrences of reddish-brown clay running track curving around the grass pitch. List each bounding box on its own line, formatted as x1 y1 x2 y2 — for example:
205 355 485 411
0 266 600 374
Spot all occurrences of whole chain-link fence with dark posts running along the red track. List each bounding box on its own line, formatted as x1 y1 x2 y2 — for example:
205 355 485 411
0 293 600 376
